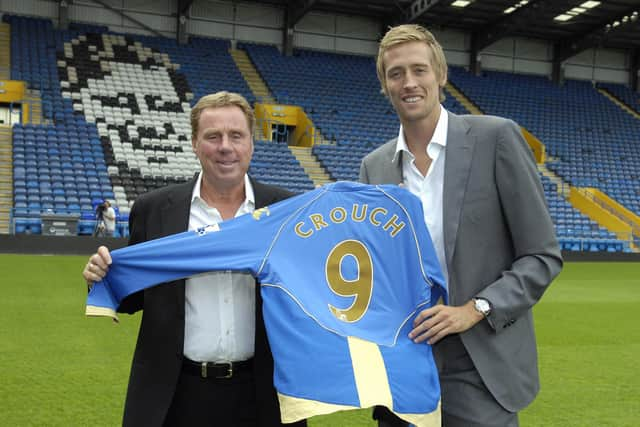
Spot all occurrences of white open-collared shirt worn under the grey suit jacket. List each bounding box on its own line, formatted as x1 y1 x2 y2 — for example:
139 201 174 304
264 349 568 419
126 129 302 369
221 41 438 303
394 105 449 283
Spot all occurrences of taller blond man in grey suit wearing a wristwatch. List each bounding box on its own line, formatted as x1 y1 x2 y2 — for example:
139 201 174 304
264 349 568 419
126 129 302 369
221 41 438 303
360 25 562 427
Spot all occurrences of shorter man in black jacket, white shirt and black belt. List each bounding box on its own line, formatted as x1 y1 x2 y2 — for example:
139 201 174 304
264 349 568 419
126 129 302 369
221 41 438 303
83 92 305 427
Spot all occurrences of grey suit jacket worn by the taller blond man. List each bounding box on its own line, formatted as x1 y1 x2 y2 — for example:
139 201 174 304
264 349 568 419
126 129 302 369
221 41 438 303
360 113 562 411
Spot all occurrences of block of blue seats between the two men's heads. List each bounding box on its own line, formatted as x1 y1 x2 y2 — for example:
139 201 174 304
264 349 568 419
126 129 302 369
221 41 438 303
239 43 468 180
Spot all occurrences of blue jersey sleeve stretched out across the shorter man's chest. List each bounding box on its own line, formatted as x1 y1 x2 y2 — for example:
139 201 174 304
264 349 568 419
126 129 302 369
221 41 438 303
86 198 310 318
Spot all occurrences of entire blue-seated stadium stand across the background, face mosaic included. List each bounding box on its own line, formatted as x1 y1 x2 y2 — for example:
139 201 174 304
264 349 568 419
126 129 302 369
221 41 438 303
3 15 640 252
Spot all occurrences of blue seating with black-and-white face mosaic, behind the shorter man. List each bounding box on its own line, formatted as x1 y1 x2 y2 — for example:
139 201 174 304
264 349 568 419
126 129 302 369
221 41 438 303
3 15 313 235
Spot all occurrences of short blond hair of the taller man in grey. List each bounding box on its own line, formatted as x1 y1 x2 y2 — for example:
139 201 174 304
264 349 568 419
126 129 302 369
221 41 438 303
376 24 447 102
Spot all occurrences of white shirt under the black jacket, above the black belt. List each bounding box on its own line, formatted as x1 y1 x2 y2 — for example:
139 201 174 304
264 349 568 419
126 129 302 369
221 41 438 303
184 172 256 362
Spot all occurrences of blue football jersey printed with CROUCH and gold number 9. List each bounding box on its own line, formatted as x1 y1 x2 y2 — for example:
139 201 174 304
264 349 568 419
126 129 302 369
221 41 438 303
86 182 446 426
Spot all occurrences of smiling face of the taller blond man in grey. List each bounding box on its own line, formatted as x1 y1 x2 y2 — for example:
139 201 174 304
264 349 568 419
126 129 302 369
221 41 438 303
383 41 446 126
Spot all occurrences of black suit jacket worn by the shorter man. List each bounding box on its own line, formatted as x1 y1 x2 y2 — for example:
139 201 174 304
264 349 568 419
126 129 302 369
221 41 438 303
119 179 304 427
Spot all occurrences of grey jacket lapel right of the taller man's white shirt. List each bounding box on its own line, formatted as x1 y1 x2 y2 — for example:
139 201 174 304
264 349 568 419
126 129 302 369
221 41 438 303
442 113 475 266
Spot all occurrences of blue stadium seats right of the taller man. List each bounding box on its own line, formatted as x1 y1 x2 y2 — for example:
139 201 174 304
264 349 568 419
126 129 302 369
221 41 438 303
450 67 640 251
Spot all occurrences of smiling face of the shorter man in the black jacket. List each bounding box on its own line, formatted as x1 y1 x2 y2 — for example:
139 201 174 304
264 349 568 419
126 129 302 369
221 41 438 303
192 106 253 188
